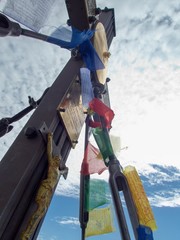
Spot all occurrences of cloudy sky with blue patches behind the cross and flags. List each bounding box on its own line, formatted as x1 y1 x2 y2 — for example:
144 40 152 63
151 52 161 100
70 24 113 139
0 0 180 240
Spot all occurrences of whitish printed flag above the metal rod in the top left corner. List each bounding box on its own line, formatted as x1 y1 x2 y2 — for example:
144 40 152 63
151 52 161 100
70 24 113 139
3 0 55 32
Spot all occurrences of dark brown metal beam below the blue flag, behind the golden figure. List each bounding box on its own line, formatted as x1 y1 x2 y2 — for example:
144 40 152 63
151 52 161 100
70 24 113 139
0 59 83 240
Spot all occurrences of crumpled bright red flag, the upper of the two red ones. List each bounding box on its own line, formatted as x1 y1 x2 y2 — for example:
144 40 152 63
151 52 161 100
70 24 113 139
89 98 114 128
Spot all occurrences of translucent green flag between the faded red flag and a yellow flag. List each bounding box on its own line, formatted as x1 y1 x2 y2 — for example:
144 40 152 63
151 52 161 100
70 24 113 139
85 179 110 211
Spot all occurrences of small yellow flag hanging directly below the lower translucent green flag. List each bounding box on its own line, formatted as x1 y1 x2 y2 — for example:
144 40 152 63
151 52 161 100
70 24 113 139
85 207 115 237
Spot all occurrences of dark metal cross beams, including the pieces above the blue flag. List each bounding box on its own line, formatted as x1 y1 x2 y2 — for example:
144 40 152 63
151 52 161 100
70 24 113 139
0 0 115 240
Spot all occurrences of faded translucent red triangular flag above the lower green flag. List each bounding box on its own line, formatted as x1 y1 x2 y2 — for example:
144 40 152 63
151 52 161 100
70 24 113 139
81 142 107 175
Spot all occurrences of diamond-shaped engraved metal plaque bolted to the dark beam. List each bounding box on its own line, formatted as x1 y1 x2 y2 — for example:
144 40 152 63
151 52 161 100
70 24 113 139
57 80 86 148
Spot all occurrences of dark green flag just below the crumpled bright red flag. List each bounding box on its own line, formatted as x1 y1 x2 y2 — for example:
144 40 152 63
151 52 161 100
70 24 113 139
92 128 114 166
